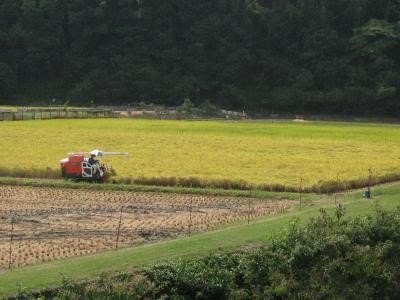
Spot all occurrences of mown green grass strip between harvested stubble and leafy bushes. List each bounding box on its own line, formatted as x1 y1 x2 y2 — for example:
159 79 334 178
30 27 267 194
0 185 400 296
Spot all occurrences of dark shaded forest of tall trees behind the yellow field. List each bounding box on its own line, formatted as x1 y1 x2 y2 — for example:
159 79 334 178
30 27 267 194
0 0 400 116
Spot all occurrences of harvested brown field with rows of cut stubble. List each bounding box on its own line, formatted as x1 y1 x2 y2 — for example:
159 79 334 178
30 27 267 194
0 186 294 269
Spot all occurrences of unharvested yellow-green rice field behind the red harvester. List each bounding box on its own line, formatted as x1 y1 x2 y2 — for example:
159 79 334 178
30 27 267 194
0 119 400 187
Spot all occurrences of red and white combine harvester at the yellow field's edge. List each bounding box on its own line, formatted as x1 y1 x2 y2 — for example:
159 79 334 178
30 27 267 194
60 150 128 182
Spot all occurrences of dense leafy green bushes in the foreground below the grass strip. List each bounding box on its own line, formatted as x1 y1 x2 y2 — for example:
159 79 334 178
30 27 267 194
16 206 400 300
